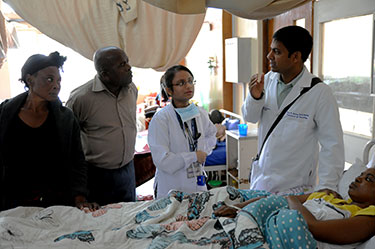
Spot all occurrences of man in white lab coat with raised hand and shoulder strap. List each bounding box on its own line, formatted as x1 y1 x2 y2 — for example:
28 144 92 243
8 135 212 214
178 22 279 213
242 26 345 194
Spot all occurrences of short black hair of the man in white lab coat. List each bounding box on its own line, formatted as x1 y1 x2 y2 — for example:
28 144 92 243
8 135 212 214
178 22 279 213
272 26 313 62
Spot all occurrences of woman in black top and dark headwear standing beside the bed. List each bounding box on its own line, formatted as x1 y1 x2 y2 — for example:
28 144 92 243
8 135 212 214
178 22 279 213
0 52 98 210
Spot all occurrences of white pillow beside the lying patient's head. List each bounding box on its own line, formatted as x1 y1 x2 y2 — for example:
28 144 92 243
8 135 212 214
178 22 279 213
338 158 367 200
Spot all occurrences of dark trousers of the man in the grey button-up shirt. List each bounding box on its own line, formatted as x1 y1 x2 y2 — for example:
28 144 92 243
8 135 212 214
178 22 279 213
88 160 135 205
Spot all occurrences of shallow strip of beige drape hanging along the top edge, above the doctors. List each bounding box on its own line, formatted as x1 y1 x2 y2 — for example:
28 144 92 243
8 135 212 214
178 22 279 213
143 0 311 19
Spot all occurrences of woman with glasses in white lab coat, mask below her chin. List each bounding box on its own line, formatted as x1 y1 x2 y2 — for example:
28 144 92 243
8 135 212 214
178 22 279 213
148 65 217 199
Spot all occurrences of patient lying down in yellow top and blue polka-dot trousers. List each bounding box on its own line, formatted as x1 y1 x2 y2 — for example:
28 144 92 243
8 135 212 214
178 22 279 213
214 168 375 248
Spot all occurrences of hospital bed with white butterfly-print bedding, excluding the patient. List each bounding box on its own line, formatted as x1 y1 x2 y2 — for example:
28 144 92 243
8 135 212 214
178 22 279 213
0 140 375 249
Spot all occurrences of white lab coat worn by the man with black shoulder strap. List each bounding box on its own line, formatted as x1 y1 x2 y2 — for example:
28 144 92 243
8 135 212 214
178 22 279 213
242 68 345 192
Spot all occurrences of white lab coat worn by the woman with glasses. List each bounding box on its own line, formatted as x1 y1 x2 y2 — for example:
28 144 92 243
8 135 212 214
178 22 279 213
148 104 216 199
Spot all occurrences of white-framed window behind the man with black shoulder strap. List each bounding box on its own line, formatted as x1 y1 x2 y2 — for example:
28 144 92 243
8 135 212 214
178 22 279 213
313 0 375 163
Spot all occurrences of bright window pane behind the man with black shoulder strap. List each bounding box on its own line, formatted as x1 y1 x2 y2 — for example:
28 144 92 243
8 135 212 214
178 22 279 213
322 15 373 137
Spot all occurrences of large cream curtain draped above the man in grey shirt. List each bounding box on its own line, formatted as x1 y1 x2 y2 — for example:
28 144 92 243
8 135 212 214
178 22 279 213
4 0 205 71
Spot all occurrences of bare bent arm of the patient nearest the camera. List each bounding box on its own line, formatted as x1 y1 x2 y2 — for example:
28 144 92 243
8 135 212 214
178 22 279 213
286 196 375 244
